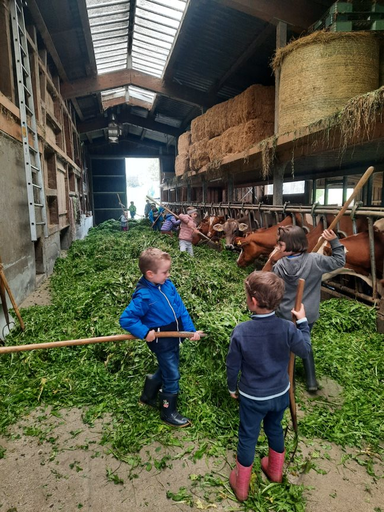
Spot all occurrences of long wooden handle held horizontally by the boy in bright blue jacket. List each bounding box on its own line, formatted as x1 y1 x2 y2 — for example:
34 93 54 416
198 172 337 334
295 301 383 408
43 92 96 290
0 331 196 354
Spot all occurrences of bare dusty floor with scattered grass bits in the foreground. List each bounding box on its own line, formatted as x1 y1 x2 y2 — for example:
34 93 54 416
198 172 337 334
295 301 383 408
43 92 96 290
0 282 384 512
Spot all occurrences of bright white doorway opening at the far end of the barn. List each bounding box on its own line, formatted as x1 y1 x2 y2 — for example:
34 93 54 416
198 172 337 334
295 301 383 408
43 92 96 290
125 158 160 219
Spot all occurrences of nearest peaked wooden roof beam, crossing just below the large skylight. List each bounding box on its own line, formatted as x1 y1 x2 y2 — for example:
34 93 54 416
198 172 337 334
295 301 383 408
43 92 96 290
61 69 218 107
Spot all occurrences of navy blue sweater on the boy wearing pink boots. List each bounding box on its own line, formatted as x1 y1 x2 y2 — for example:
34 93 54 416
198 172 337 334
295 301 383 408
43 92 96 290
227 313 311 399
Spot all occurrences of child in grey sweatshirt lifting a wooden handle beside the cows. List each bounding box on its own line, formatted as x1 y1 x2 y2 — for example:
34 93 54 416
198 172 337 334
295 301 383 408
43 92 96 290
270 225 345 392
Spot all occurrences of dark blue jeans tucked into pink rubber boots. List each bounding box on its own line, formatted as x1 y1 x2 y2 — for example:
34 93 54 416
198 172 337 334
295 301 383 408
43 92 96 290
237 391 289 467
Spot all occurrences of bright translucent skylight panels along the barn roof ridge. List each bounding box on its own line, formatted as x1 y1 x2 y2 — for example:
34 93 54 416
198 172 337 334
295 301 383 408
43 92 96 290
86 0 187 107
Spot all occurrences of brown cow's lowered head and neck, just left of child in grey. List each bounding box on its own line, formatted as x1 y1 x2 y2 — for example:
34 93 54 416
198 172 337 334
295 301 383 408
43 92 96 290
236 216 292 267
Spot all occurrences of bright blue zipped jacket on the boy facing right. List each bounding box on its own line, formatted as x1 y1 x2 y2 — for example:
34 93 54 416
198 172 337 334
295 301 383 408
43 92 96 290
120 276 196 352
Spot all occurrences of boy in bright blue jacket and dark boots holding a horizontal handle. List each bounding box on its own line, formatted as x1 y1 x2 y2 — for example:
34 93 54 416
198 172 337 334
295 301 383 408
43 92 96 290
120 247 202 427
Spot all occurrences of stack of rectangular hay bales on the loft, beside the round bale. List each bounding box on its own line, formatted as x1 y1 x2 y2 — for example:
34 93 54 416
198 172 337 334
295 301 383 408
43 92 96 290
175 84 275 173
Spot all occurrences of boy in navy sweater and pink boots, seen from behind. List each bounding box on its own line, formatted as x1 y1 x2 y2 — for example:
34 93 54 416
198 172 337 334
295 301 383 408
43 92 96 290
227 271 311 501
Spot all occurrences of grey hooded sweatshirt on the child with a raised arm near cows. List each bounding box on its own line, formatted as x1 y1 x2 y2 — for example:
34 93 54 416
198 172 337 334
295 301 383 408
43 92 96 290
272 238 345 324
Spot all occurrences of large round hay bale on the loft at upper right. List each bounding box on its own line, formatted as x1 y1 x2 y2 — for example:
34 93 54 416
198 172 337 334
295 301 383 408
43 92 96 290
273 32 380 133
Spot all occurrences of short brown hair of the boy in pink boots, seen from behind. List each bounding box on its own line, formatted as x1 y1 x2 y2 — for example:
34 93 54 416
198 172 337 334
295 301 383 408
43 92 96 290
244 270 285 311
